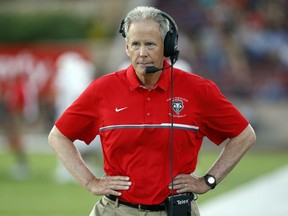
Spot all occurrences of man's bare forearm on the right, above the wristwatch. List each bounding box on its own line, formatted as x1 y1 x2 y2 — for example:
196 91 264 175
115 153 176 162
208 125 256 183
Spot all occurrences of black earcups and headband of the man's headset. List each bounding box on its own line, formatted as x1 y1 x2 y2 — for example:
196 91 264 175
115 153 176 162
119 11 179 65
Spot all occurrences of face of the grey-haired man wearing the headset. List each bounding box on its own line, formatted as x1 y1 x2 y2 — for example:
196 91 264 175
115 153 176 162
126 20 164 76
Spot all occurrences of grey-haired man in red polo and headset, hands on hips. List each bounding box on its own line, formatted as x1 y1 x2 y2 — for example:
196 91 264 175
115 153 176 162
49 7 255 216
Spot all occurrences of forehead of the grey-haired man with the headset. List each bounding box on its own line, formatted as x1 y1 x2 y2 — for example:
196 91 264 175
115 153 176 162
127 20 161 40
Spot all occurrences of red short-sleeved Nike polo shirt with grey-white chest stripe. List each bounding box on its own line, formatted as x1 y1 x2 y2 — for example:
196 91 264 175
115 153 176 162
56 61 248 204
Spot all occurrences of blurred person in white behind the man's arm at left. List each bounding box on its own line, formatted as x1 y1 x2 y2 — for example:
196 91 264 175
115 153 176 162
55 51 100 183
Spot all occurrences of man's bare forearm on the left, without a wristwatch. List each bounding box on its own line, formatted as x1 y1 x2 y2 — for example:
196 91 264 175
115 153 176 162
48 126 95 186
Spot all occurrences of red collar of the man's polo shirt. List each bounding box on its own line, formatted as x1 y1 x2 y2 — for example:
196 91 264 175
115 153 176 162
126 60 170 91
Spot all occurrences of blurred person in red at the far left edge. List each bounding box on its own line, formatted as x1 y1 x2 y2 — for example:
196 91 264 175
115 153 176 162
0 73 29 179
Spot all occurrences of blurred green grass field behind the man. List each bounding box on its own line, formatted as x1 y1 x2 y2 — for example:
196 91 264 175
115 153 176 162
0 152 288 216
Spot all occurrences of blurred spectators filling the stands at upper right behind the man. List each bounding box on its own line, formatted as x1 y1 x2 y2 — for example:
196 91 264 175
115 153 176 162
156 0 288 101
